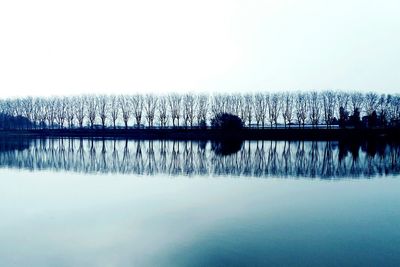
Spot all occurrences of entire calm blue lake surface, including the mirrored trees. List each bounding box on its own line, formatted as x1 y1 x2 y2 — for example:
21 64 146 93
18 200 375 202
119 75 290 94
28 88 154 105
0 139 400 266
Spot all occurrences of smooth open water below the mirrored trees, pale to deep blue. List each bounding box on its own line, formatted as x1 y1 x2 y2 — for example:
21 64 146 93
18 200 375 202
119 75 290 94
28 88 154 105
0 169 400 266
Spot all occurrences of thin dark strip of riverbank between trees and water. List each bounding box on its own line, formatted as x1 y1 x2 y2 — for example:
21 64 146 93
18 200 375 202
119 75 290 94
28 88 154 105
0 128 400 140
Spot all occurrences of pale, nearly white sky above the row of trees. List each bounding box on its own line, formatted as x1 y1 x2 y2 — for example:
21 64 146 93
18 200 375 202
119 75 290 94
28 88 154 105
0 0 400 98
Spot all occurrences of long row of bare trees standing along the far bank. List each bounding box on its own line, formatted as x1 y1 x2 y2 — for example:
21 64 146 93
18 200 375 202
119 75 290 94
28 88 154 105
0 91 400 129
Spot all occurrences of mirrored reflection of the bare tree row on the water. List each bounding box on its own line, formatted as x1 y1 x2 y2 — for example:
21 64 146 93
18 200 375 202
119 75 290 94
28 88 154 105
0 139 400 178
